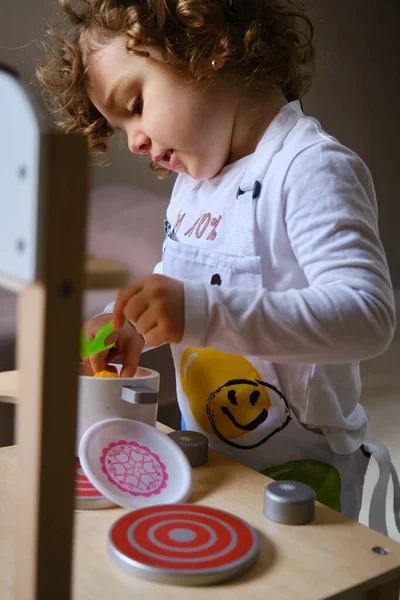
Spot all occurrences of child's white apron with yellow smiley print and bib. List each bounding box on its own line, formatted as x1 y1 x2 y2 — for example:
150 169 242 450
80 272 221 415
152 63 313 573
163 141 400 533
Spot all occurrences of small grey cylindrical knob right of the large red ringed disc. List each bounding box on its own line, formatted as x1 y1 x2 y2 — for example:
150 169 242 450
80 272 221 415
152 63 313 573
264 480 315 525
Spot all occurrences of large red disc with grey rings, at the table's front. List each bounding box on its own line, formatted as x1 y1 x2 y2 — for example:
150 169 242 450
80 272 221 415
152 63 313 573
108 504 258 585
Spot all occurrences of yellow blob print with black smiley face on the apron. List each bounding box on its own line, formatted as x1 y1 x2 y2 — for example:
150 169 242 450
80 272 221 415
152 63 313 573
180 348 290 449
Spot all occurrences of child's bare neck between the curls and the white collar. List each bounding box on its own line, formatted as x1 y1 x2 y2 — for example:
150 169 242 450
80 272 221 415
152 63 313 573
227 90 287 164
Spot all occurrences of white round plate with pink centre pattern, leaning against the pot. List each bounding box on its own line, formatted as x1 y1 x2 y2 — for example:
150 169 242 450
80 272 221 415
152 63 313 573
79 419 192 509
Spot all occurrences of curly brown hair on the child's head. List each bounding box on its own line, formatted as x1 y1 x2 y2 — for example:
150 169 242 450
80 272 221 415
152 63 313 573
37 0 314 172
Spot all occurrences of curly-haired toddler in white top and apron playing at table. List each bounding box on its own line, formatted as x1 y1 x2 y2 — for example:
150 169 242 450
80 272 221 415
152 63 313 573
39 0 395 529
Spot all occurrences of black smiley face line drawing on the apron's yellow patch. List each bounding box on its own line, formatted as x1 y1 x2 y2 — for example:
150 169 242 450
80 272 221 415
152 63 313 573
206 379 292 450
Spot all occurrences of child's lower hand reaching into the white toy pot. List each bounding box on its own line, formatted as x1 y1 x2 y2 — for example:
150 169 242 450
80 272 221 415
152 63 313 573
82 313 144 377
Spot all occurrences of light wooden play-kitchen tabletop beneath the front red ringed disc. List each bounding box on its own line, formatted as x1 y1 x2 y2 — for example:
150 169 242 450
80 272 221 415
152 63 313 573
0 425 400 600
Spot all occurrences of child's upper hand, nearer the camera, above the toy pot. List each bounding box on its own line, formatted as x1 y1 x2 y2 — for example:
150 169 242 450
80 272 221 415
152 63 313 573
113 274 185 346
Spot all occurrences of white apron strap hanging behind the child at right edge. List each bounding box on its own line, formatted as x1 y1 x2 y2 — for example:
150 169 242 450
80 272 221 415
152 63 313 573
364 437 400 536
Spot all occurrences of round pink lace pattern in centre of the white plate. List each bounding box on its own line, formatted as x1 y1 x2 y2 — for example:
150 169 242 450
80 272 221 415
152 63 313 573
100 440 168 497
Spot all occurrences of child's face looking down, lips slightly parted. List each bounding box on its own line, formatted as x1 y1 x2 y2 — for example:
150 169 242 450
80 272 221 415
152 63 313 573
85 37 238 179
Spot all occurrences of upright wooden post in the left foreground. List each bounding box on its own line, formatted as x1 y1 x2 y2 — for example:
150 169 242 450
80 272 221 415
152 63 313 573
13 134 87 600
